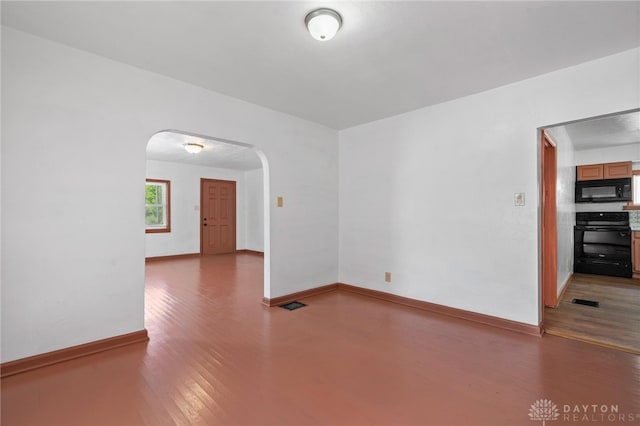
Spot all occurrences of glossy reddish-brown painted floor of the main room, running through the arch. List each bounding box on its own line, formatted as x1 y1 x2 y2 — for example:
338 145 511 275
2 254 640 426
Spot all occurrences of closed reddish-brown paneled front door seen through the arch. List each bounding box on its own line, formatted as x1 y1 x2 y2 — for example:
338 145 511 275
200 179 236 254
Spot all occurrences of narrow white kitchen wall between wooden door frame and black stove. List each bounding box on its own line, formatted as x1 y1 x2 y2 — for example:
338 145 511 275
548 127 576 295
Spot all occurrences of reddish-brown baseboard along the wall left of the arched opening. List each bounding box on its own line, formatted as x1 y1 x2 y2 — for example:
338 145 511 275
0 329 149 378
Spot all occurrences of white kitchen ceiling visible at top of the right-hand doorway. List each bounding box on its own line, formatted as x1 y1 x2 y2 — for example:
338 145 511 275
550 111 640 150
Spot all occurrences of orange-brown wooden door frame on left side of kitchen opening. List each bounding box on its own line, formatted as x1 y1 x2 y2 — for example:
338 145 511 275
540 130 558 320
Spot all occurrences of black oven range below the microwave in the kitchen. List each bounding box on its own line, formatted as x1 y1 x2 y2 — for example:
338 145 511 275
573 212 633 278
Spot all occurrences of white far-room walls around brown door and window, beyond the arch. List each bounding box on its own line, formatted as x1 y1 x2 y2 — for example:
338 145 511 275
145 160 264 257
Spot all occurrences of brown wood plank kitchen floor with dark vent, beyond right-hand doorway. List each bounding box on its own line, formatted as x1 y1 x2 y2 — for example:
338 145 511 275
544 274 640 354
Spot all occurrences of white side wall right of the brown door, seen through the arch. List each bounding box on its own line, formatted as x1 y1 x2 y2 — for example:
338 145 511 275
244 169 264 251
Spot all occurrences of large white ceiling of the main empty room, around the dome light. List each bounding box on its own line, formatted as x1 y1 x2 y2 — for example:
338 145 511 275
1 1 640 129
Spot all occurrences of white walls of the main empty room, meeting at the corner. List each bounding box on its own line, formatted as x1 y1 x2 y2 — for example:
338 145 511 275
1 23 640 362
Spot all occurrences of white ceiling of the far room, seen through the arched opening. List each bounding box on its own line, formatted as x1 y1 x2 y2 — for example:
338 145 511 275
147 131 262 170
